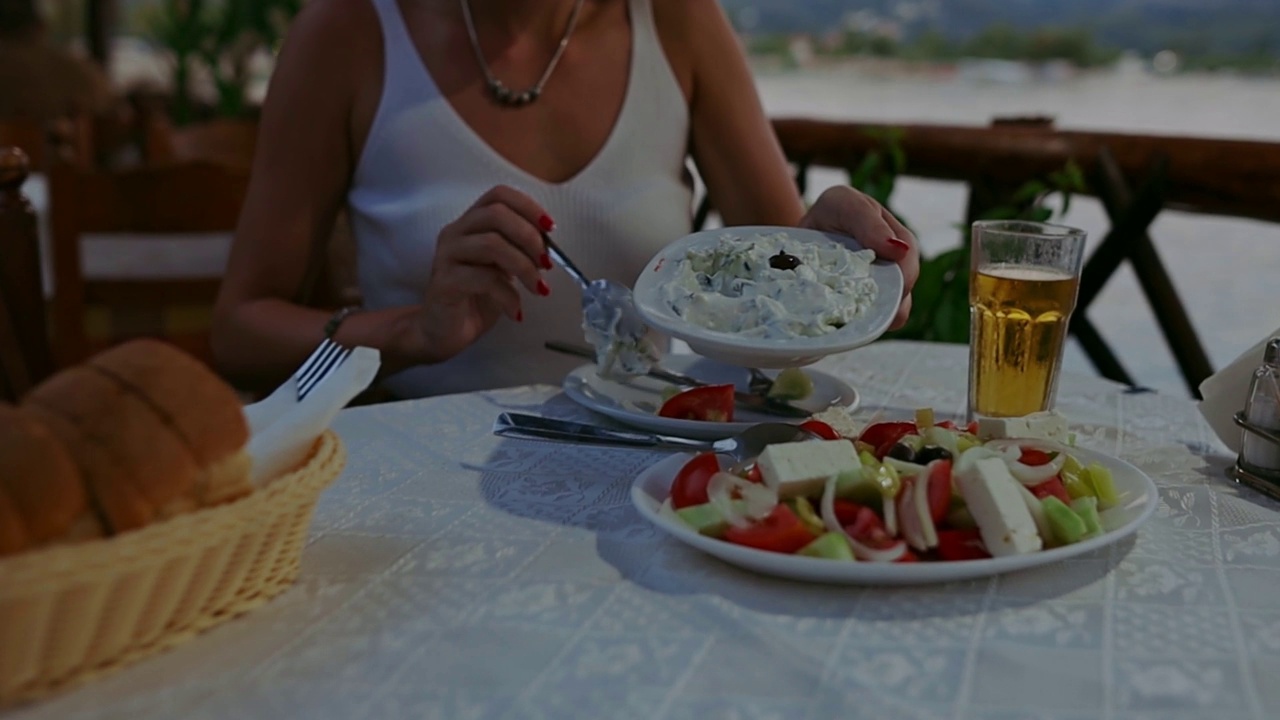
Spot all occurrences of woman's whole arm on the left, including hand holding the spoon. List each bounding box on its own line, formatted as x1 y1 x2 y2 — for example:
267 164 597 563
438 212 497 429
212 0 553 387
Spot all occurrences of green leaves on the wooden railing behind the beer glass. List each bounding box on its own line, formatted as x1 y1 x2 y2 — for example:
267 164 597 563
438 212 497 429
849 128 1085 343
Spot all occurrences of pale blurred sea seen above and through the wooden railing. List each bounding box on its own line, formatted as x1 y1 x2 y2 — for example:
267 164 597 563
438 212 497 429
756 61 1280 402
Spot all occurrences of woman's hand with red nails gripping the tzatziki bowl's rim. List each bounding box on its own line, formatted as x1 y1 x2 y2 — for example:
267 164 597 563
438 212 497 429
800 186 920 329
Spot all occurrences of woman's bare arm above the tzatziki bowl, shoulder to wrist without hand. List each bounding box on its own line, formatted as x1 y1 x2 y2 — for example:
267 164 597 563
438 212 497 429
654 0 804 225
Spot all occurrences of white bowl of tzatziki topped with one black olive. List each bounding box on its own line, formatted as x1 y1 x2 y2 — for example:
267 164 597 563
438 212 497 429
634 225 902 368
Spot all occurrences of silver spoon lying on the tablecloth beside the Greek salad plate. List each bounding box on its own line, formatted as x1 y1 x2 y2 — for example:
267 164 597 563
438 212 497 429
493 413 818 462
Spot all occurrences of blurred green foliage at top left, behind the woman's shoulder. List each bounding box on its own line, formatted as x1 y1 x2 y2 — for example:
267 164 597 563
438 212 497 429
142 0 302 123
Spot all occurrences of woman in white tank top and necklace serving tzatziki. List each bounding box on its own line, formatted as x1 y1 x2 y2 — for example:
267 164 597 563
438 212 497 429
214 0 916 397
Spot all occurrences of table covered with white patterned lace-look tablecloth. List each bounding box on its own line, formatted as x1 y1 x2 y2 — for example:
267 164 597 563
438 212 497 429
12 342 1280 720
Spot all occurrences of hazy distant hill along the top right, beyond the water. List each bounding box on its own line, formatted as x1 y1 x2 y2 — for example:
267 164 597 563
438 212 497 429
722 0 1280 54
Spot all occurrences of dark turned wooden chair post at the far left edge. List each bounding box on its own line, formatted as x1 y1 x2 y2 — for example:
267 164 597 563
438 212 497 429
0 147 54 402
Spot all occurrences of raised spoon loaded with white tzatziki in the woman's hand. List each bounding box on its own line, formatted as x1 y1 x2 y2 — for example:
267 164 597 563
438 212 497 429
543 232 658 375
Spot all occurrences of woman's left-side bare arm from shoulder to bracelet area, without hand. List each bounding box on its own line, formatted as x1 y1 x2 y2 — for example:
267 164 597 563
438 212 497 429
212 1 424 384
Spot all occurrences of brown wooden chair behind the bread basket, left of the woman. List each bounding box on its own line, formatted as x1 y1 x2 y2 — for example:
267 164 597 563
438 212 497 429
49 163 248 365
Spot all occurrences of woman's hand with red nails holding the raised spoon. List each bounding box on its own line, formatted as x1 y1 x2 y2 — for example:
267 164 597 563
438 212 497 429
416 186 556 363
